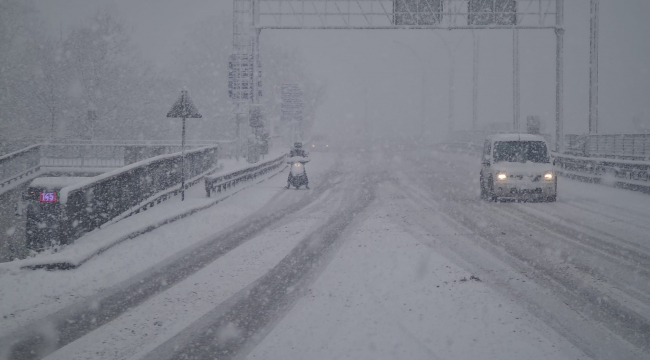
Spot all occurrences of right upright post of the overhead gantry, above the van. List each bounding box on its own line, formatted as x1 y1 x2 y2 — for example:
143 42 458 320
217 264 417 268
555 0 564 153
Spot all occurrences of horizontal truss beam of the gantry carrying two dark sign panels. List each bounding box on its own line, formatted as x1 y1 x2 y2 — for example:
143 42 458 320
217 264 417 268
253 0 561 29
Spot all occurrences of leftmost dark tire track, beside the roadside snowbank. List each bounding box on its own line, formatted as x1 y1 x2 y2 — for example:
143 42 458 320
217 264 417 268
0 167 341 360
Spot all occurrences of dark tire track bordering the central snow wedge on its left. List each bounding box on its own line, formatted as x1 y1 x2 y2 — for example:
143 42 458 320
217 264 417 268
137 169 386 360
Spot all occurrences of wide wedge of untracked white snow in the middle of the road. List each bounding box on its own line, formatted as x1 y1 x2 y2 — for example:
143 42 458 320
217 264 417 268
247 183 586 360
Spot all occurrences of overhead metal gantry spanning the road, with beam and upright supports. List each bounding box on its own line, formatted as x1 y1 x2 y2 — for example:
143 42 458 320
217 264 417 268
229 0 564 151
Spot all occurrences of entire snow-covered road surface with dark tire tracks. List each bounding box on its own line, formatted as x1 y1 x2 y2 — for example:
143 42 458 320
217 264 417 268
0 149 650 359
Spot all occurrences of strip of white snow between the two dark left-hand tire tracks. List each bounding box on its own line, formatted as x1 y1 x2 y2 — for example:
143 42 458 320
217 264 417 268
46 183 342 360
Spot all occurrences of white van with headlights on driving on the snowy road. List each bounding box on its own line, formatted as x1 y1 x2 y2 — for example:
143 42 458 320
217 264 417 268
480 134 557 201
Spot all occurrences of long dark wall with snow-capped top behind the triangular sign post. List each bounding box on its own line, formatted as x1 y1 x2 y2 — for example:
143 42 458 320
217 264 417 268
59 145 218 242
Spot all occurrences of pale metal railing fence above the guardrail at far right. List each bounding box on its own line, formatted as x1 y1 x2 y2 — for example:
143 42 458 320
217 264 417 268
565 134 650 160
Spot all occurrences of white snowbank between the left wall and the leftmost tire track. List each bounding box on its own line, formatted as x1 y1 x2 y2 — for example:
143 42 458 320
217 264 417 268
0 154 335 337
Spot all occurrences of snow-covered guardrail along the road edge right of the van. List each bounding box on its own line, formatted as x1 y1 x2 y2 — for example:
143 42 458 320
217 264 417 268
553 154 650 194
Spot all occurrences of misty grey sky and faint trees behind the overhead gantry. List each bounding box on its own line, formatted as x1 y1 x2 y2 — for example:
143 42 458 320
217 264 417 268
0 0 650 151
